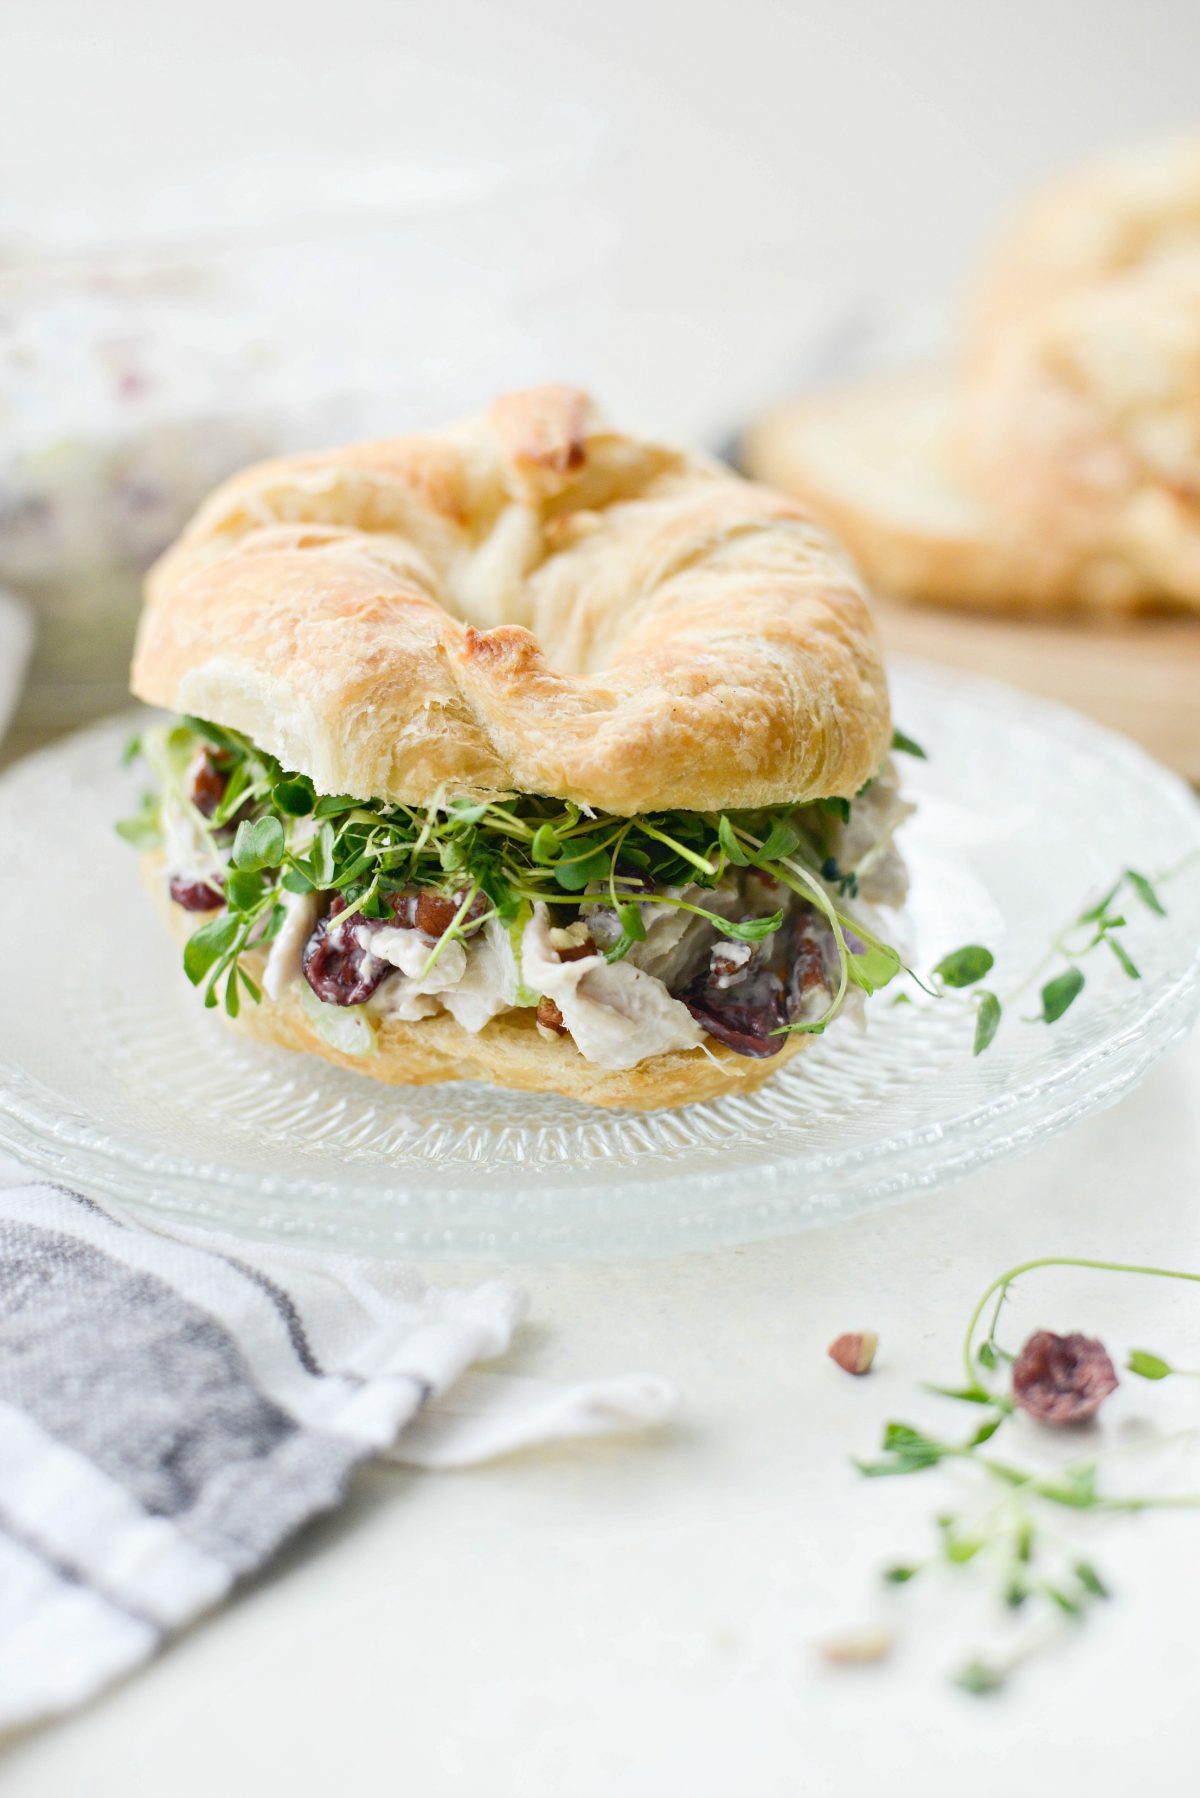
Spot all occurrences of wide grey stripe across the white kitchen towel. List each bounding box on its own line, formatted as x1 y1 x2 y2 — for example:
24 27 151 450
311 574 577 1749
0 1221 365 1571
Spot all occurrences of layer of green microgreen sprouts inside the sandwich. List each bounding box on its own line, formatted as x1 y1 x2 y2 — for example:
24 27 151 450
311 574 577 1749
119 717 901 1032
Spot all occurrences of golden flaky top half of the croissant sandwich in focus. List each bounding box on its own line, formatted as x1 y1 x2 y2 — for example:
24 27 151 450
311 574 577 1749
133 387 891 814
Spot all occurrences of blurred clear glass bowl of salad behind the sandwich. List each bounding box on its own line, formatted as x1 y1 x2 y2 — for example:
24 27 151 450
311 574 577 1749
0 155 608 730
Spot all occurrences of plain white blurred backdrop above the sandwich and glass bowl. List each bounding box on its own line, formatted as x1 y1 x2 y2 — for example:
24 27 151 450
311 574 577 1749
0 0 1200 437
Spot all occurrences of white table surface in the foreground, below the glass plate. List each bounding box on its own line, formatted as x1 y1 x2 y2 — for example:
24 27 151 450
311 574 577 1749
9 1036 1200 1798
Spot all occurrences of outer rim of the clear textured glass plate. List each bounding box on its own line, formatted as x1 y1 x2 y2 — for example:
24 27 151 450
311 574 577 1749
0 662 1200 1260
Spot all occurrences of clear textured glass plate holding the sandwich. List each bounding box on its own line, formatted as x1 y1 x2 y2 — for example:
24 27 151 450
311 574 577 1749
0 663 1200 1260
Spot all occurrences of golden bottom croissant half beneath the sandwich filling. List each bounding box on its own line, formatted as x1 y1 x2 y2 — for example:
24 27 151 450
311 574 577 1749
142 854 811 1111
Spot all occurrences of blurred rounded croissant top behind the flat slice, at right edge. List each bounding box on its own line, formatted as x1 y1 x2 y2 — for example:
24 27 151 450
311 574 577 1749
954 137 1200 606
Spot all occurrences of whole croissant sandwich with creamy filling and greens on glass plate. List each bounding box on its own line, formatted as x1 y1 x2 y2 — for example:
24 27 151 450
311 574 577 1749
122 387 907 1108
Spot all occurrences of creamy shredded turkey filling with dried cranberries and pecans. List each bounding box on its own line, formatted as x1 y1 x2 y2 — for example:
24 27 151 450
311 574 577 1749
284 870 837 1070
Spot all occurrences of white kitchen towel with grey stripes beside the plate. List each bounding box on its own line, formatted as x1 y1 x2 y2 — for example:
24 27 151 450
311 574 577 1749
0 1163 675 1730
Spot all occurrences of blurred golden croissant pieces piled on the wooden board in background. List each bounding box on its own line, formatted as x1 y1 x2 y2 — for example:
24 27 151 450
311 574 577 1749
743 137 1200 615
